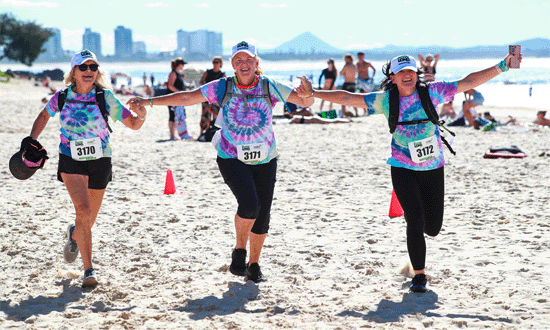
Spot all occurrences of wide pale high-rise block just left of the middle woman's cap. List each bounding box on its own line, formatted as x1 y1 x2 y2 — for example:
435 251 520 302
176 29 223 56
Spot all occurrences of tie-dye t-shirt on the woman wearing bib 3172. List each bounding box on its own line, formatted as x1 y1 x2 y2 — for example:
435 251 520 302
364 81 458 171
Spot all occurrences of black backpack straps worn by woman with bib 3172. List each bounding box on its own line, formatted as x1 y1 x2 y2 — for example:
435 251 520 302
388 83 456 155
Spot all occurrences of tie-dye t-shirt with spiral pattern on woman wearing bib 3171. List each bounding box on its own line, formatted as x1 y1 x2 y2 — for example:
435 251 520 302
201 76 292 165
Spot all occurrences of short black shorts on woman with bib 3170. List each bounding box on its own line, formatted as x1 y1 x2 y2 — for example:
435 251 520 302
57 154 113 190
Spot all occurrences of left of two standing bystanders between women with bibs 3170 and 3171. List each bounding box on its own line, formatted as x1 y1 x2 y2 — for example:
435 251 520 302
166 57 193 140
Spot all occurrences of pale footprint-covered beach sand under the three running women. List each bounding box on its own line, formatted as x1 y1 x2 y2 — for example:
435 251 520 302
0 81 550 329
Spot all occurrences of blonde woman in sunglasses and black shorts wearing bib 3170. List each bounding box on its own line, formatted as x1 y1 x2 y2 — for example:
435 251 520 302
30 50 147 287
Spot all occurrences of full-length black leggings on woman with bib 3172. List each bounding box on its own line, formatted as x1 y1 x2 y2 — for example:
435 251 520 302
391 166 445 270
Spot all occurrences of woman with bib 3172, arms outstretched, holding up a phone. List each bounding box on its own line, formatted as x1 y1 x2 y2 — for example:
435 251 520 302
299 55 521 292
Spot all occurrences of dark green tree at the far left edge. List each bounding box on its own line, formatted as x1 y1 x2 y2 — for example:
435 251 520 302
0 14 53 66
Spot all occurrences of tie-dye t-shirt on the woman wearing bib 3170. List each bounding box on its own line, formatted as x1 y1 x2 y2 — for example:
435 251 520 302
46 86 131 157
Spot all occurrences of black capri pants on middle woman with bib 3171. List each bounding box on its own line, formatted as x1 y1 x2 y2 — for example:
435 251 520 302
217 157 277 235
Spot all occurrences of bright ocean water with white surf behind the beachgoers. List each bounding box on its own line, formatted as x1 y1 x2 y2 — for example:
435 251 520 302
4 58 550 109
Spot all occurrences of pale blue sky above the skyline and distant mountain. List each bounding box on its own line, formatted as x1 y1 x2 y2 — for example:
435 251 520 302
0 0 550 54
